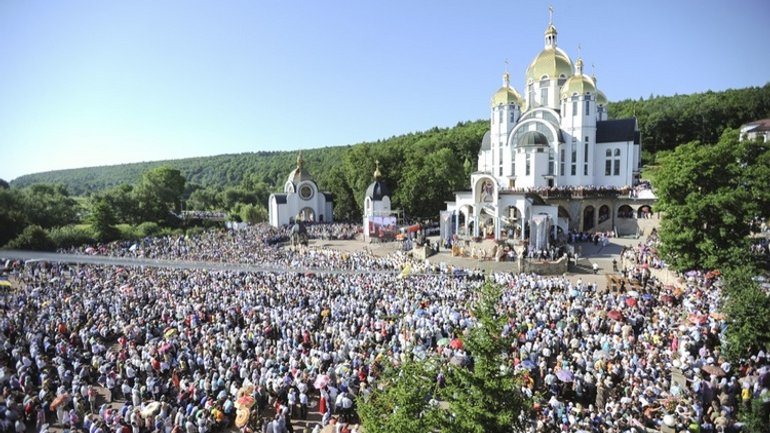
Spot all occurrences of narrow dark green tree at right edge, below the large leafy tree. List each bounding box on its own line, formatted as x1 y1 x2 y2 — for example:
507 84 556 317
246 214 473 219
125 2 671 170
722 266 770 361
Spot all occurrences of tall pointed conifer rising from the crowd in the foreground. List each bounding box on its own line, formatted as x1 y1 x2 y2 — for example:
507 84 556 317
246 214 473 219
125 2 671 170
442 282 529 433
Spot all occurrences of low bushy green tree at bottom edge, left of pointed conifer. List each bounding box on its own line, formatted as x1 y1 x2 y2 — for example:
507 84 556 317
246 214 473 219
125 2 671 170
356 360 446 433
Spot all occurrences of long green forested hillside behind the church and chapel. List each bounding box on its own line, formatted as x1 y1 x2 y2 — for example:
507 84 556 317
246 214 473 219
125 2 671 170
11 84 770 219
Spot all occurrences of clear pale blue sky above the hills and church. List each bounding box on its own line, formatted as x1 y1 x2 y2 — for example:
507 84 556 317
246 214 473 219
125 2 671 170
0 0 770 180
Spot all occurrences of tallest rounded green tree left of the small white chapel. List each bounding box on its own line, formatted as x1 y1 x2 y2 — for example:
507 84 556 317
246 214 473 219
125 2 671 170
134 166 185 224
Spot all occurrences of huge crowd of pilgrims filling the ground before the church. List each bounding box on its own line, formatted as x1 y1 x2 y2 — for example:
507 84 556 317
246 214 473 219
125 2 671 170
0 223 770 433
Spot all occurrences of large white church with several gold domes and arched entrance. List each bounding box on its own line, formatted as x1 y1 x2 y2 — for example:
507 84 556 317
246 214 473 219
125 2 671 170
441 12 652 249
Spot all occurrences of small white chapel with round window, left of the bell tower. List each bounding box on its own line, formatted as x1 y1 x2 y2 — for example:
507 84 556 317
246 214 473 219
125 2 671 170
268 154 334 227
